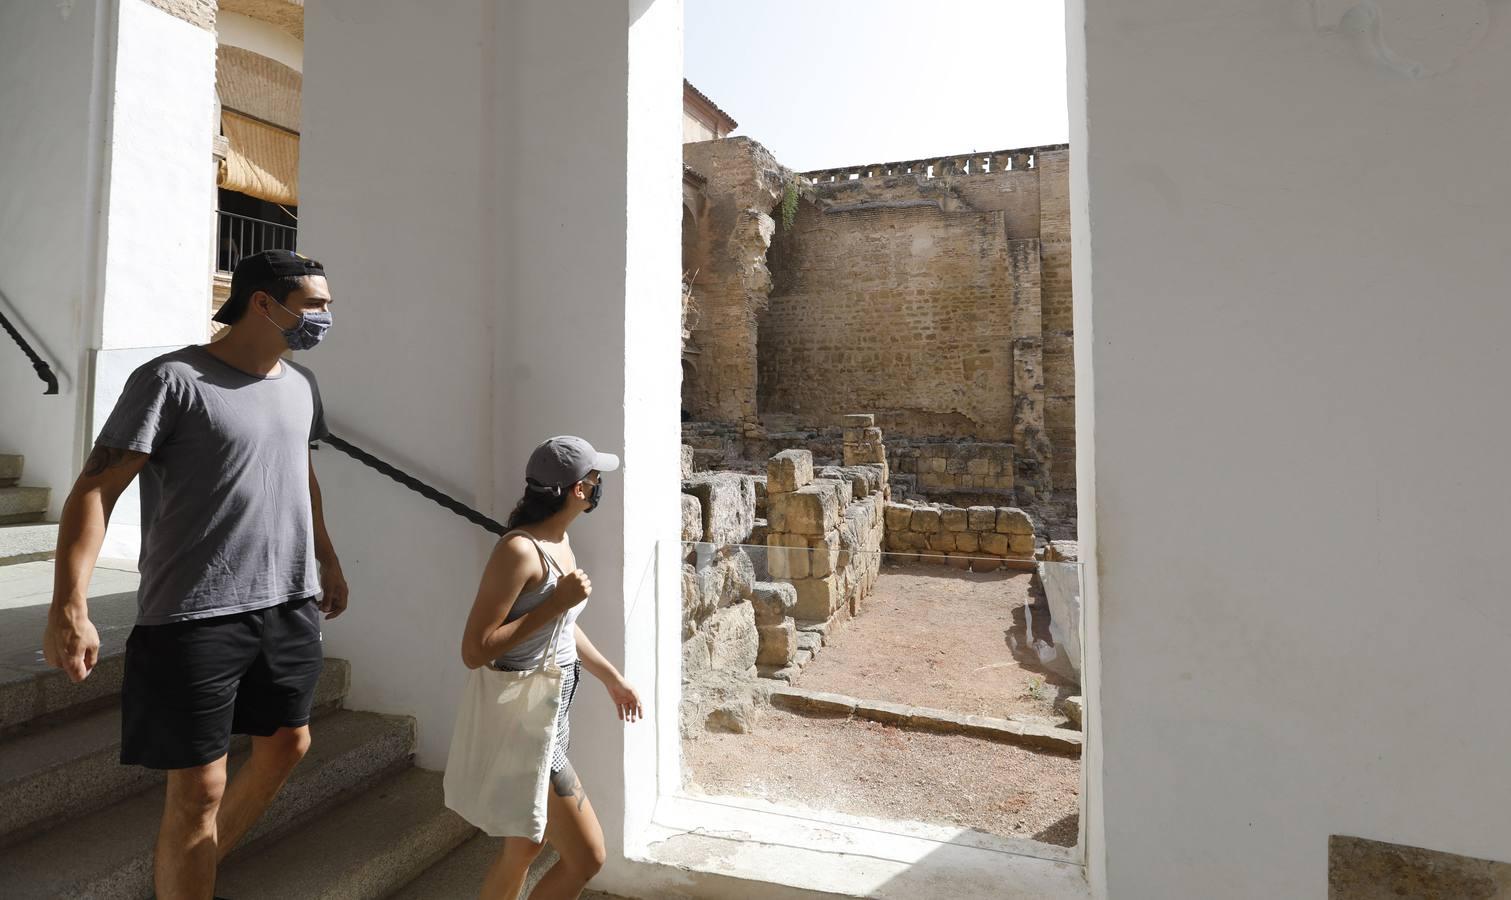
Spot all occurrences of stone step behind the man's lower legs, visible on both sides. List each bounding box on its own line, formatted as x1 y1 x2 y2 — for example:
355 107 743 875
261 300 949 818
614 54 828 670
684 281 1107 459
0 711 414 900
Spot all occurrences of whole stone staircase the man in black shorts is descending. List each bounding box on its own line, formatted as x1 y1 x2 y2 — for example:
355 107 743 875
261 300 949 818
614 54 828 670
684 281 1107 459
0 560 625 900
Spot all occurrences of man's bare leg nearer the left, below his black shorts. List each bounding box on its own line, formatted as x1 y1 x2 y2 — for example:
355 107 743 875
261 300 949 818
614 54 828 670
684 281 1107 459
153 757 225 900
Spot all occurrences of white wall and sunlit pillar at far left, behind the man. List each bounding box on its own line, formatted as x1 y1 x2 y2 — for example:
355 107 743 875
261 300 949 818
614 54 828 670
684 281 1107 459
0 0 215 557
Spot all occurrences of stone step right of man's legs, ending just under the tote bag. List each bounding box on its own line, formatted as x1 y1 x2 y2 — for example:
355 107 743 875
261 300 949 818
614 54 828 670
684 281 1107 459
215 769 482 900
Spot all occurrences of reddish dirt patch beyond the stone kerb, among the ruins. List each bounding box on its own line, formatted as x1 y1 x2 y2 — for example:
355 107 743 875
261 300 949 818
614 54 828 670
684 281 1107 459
795 565 1080 725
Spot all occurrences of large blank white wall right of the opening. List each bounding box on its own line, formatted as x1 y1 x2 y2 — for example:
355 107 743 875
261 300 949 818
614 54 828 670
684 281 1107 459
1068 0 1511 900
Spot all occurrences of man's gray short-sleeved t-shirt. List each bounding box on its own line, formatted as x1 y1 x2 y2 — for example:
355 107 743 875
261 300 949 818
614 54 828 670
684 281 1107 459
98 346 326 625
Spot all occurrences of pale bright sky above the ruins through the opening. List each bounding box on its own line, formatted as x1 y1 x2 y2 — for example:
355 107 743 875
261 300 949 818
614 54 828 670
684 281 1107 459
683 0 1070 172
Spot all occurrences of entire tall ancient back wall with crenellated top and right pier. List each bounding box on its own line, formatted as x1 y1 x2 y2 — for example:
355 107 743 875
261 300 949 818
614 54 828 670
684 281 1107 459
759 145 1074 503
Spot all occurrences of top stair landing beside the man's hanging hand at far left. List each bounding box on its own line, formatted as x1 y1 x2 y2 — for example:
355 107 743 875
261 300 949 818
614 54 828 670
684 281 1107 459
0 562 139 737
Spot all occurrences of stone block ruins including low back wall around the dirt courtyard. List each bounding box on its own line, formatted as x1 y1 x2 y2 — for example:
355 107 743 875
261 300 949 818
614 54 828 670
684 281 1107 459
681 415 1079 737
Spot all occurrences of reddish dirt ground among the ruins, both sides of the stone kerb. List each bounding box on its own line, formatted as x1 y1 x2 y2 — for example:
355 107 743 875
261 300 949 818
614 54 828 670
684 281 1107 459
683 565 1080 847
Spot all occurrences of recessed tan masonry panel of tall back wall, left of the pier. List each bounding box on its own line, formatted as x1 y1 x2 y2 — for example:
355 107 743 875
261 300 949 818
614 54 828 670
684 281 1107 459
759 200 1012 441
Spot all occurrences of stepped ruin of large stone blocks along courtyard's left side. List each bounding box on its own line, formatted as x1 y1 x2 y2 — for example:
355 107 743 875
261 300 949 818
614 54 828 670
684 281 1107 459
681 415 888 735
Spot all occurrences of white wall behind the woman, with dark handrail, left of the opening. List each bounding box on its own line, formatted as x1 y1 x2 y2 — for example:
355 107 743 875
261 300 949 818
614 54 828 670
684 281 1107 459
301 0 681 879
